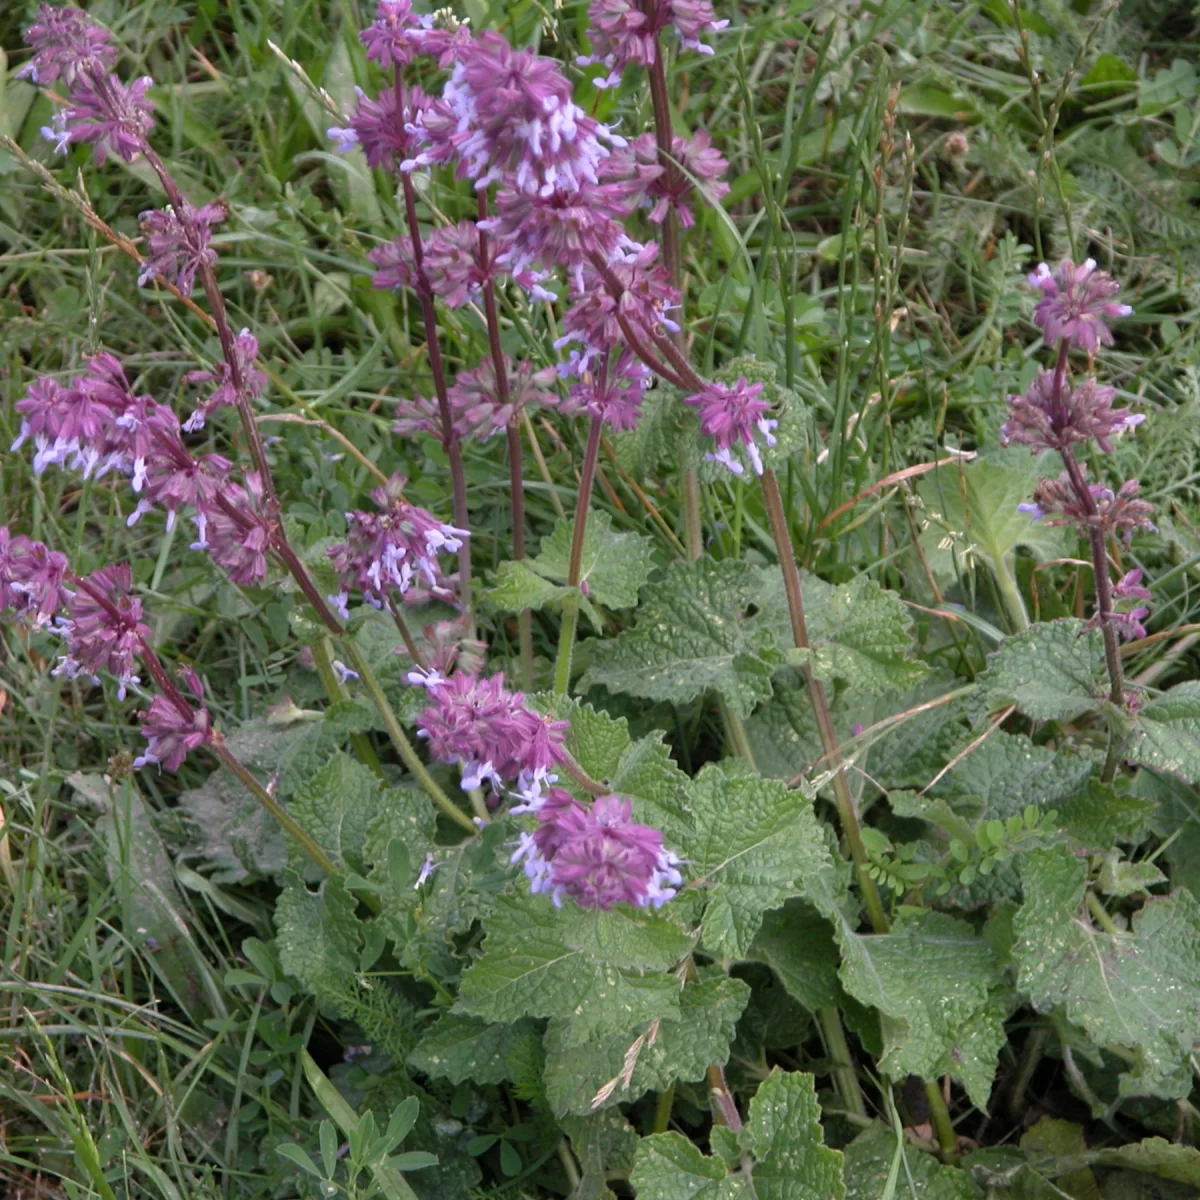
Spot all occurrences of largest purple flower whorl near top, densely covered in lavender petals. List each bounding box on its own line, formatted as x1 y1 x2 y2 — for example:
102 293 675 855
414 30 623 194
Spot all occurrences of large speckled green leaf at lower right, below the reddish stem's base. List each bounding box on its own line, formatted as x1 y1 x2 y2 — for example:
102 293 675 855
841 910 1008 1109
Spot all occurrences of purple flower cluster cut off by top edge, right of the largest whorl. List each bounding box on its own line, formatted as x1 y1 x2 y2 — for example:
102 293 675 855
578 0 728 88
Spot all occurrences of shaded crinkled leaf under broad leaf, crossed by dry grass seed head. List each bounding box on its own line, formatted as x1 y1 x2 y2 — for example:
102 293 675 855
546 976 750 1115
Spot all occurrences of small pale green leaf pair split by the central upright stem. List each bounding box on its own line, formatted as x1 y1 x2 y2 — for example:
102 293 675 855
485 510 654 632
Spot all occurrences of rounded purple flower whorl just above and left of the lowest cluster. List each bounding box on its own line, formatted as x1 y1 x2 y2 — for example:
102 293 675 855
416 671 568 796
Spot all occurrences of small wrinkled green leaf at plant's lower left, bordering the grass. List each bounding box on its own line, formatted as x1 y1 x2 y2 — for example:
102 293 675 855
275 870 362 992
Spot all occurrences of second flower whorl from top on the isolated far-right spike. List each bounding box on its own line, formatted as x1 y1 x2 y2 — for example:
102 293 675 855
1000 371 1145 454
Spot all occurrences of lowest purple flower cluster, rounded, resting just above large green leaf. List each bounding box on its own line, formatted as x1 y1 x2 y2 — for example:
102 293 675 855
512 787 683 910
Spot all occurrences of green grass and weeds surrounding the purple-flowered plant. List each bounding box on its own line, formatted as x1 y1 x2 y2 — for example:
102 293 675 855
7 0 1200 1200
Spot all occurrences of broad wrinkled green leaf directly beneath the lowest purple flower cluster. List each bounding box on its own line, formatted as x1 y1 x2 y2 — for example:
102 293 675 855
455 894 692 1044
